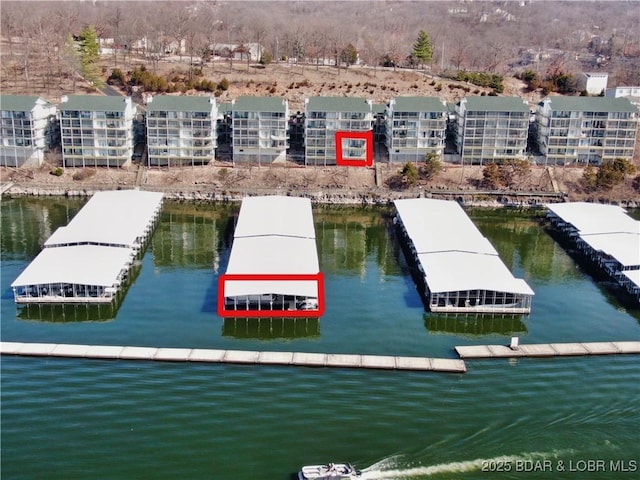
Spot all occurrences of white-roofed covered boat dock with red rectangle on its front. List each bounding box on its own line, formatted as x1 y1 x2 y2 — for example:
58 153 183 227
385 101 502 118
219 196 321 316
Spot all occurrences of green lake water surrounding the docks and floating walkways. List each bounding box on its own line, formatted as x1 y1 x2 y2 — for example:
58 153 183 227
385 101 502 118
0 198 640 480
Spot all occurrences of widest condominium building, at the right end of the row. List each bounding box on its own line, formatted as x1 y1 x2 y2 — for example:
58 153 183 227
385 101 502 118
536 96 638 165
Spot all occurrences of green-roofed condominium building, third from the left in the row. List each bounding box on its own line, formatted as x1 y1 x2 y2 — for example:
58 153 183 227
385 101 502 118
147 95 218 167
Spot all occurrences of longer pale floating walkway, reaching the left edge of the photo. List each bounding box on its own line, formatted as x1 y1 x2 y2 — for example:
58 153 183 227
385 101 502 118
0 342 467 373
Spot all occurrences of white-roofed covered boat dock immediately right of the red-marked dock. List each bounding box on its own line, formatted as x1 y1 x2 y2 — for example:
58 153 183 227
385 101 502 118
394 198 534 314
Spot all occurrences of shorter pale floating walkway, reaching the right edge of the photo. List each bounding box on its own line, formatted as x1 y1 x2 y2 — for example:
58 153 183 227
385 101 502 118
455 341 640 359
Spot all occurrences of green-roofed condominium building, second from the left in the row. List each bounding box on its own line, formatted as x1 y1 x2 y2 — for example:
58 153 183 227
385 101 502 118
60 95 136 167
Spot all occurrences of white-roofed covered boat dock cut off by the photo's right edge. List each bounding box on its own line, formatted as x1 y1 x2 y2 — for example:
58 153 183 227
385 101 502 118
547 202 640 303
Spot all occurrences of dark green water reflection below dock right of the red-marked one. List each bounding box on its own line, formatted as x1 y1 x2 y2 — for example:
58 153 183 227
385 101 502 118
424 314 527 336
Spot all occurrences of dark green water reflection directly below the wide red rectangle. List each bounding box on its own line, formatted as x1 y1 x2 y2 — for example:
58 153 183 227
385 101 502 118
222 317 320 340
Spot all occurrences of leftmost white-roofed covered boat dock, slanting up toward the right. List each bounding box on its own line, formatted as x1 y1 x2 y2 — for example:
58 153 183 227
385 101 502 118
11 190 162 304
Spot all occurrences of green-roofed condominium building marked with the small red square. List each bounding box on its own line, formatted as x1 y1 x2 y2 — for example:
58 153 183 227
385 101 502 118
305 97 373 166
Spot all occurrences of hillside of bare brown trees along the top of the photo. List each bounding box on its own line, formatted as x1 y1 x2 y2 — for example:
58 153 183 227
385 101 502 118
0 0 640 94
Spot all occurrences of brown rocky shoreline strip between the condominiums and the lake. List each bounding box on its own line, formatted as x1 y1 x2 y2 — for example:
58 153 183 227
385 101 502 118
5 164 640 208
